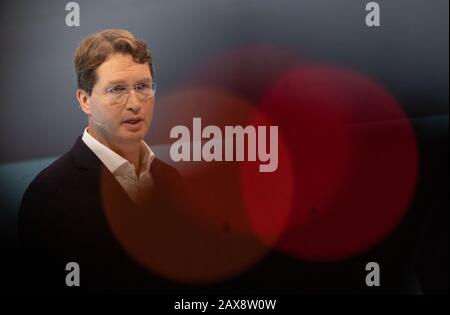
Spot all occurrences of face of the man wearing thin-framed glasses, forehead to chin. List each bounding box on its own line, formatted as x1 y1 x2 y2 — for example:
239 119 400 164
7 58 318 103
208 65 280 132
89 54 154 145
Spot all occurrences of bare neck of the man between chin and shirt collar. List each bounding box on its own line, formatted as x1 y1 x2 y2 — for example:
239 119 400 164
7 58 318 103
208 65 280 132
88 126 141 175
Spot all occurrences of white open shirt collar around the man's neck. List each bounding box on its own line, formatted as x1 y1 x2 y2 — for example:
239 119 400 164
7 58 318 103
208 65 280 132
82 128 156 174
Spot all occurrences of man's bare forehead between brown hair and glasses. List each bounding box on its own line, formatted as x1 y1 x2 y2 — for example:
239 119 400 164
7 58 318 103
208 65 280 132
96 54 152 83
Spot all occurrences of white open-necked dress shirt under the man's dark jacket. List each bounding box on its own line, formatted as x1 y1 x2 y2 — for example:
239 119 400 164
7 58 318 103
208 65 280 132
81 128 155 204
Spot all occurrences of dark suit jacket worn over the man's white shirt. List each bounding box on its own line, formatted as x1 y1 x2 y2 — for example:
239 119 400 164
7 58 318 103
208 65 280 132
19 137 188 291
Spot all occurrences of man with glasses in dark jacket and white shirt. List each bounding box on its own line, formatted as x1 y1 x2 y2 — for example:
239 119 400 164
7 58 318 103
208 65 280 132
19 29 180 289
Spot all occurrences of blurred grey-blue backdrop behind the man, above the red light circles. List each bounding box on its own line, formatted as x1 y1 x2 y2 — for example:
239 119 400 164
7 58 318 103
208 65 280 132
0 0 449 163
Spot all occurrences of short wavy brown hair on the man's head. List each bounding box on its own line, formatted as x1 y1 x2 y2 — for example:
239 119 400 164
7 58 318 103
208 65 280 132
74 29 153 95
